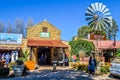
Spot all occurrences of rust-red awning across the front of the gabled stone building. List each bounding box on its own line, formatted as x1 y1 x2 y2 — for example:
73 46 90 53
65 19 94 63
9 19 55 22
27 39 68 48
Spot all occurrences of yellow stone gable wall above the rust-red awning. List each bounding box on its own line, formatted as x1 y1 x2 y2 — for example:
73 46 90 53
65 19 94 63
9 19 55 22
27 21 61 40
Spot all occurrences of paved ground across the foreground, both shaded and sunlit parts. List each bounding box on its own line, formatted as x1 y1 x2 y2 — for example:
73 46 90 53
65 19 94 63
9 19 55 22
0 67 119 80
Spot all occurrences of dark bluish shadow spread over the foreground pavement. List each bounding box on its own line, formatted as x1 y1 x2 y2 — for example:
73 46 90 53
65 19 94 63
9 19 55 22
0 70 93 80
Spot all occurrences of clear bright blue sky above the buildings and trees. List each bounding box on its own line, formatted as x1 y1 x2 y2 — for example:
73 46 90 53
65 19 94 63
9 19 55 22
0 0 120 40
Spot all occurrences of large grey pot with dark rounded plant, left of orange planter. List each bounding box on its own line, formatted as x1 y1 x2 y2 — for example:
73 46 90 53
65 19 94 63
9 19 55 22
12 59 25 77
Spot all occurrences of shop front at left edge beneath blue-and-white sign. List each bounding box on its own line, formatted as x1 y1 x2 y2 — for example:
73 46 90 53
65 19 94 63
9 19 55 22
0 33 22 62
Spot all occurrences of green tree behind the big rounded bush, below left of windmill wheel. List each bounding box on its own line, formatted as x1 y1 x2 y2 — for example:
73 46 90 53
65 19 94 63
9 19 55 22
78 26 92 39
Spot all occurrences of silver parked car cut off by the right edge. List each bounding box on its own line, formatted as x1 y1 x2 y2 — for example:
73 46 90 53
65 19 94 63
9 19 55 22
110 58 120 77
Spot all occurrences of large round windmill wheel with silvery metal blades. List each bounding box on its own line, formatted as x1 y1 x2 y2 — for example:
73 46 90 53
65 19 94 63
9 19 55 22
85 2 112 31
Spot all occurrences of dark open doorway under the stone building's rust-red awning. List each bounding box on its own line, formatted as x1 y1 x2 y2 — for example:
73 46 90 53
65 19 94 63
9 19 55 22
38 47 51 65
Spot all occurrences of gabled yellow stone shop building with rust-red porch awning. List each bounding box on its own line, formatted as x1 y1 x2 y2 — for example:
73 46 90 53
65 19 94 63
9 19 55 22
27 20 68 65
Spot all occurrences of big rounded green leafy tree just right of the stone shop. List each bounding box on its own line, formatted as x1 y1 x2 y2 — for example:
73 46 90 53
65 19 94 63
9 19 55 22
69 39 95 56
